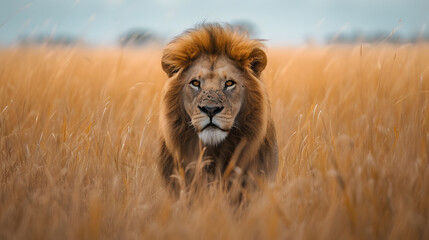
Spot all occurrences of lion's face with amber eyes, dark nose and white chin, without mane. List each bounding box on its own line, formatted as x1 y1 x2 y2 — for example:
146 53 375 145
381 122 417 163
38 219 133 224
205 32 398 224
181 56 245 145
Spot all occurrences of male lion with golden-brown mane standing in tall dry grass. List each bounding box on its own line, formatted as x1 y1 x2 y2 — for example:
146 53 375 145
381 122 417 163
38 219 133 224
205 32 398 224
159 23 278 195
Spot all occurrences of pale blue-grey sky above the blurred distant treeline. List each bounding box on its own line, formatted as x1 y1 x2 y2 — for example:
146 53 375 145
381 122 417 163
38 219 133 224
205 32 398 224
0 0 429 45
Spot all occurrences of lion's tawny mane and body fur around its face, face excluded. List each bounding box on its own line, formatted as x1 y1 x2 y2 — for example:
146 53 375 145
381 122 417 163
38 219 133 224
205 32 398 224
159 24 278 194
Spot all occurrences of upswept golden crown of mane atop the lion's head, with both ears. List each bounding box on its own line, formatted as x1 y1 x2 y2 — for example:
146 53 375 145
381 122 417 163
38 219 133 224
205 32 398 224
162 24 266 76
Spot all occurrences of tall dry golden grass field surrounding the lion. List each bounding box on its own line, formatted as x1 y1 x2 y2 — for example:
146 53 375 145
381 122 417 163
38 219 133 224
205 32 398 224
0 44 429 239
